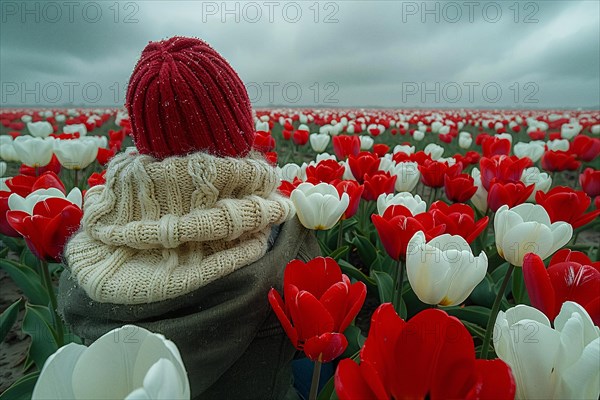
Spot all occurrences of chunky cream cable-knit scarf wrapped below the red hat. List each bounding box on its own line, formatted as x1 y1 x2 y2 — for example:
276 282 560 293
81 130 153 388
65 152 294 304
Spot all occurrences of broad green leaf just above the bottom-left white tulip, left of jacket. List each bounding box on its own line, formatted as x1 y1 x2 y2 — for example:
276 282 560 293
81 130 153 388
23 304 58 369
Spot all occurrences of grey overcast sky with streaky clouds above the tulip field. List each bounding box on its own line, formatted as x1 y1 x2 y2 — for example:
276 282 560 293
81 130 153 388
0 0 600 108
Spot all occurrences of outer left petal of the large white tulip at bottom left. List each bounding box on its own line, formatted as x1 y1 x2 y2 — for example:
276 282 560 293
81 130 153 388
31 343 87 400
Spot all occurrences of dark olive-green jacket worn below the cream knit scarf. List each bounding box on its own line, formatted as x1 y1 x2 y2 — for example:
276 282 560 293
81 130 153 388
58 218 320 400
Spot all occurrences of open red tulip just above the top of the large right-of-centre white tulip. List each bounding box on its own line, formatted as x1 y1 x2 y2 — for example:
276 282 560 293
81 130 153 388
429 201 489 244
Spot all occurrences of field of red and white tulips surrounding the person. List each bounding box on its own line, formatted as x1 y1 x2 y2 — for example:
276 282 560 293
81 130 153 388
0 109 600 400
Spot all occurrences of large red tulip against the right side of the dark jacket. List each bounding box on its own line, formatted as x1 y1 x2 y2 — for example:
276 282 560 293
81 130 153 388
269 257 367 362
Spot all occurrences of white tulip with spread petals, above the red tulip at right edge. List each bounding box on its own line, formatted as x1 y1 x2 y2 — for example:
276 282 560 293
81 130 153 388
494 203 573 267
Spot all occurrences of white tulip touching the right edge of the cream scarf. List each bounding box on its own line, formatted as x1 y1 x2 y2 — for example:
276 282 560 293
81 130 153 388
290 182 350 230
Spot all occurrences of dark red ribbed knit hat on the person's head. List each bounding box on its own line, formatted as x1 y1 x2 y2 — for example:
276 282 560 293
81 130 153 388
126 37 255 159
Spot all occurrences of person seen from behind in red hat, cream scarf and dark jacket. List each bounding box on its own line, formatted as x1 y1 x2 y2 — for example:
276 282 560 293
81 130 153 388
59 37 319 399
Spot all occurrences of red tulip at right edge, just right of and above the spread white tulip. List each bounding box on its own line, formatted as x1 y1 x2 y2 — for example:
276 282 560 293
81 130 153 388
535 186 600 229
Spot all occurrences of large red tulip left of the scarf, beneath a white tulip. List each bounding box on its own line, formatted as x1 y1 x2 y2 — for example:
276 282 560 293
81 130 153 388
6 197 83 262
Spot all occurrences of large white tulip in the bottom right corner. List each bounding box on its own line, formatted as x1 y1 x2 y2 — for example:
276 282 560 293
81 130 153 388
494 301 600 399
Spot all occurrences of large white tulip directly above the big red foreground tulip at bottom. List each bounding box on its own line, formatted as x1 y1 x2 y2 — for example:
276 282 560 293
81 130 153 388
406 231 488 306
